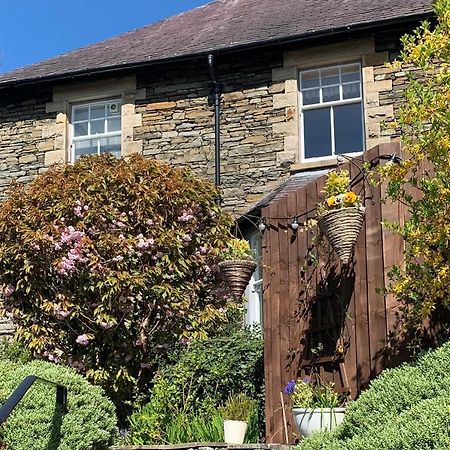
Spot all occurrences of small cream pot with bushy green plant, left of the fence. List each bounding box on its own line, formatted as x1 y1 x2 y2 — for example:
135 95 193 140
220 394 257 444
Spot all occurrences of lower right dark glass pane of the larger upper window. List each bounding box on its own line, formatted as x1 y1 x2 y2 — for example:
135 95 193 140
334 103 363 154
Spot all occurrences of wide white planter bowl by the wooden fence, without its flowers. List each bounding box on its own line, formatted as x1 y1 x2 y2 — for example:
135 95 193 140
292 408 345 437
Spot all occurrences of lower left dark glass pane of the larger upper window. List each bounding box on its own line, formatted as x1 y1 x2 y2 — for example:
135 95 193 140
303 108 331 158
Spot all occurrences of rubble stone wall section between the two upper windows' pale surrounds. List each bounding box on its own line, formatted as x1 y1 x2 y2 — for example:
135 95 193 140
134 51 286 213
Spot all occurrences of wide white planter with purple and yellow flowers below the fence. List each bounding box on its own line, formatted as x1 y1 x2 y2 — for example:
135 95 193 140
284 376 345 437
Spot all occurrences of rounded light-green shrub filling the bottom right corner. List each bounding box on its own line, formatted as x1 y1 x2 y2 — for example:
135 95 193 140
299 343 450 450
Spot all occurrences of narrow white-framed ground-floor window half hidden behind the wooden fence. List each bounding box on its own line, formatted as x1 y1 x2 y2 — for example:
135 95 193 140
244 231 264 332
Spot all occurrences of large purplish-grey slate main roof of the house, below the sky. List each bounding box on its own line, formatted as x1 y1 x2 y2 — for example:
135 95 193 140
0 0 431 87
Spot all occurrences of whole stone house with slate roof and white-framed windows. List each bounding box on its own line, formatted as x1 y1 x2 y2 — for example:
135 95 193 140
0 0 432 439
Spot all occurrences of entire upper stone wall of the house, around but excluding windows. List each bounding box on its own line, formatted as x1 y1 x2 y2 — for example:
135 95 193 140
0 37 406 215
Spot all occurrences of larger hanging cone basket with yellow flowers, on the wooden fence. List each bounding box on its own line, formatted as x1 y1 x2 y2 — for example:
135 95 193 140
318 170 365 264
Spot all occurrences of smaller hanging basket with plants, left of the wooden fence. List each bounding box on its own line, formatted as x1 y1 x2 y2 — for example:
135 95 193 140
219 238 256 300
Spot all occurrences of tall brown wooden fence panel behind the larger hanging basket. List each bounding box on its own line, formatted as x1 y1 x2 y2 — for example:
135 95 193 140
262 144 405 443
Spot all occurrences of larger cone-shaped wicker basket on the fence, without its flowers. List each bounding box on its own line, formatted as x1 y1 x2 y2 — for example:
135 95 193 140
318 207 366 264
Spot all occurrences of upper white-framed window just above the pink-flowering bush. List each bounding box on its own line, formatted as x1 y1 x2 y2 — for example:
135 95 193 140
70 99 122 162
